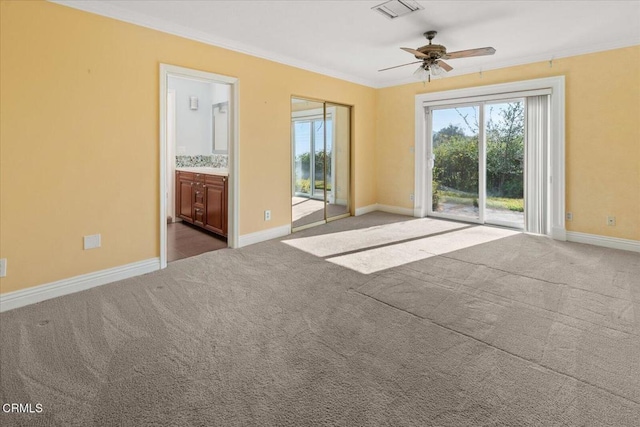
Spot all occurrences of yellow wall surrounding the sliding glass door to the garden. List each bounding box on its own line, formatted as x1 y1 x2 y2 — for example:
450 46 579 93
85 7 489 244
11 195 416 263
376 46 640 240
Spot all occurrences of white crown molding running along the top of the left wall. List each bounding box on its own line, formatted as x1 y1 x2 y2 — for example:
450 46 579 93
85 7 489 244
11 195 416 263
48 0 375 87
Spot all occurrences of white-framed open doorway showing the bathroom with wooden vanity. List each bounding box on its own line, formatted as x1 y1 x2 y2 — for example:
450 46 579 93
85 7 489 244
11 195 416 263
160 64 238 268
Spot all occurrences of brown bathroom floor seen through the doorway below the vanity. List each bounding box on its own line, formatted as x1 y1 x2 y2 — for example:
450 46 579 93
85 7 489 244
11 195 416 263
167 222 227 262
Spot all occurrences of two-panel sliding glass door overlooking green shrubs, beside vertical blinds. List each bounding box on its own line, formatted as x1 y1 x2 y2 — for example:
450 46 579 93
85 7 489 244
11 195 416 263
427 99 525 229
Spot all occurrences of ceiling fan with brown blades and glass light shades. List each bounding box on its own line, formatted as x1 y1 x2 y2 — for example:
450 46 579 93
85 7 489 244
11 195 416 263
378 31 496 81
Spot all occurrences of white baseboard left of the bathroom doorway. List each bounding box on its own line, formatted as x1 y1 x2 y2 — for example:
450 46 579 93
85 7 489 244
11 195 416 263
0 258 160 312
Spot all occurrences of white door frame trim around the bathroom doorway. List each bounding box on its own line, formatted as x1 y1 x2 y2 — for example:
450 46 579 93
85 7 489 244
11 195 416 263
159 64 240 268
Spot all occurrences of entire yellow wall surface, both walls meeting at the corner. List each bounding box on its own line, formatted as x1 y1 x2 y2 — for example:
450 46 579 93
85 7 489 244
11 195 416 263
0 1 640 293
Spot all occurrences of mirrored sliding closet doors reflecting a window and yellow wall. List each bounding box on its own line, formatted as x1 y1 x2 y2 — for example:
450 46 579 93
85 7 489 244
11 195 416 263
291 97 351 231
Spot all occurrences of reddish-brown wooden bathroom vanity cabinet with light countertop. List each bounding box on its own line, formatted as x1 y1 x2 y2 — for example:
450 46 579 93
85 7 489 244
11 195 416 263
176 167 229 237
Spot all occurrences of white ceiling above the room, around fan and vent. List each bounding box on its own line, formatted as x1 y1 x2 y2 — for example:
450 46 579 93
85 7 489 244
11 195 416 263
55 0 640 87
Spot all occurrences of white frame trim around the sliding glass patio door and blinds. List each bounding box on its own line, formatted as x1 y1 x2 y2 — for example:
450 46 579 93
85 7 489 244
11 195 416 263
413 76 567 241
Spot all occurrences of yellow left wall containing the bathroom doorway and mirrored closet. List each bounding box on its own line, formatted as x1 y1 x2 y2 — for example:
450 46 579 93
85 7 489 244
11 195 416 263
0 1 376 293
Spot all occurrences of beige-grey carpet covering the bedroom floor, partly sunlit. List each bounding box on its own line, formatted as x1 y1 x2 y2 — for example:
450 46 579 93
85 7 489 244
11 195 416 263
0 213 640 426
